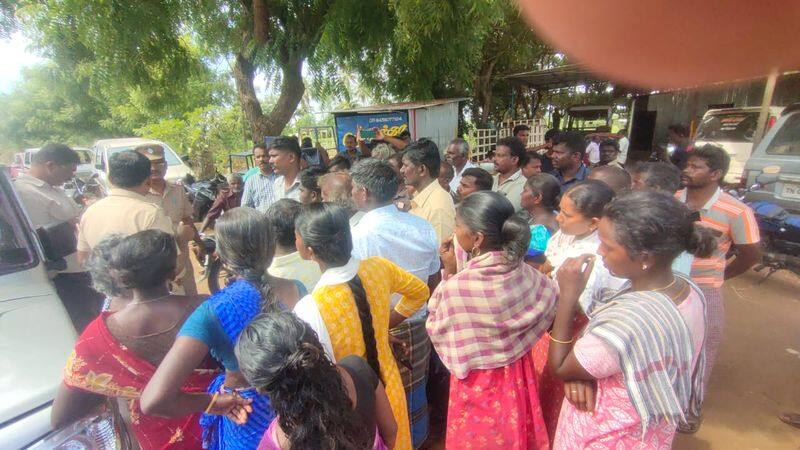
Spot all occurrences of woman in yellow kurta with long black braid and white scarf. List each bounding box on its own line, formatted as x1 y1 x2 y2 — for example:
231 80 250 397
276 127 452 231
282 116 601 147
294 203 430 450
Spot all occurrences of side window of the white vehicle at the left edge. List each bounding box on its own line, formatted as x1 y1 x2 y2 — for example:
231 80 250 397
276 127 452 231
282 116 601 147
0 183 36 275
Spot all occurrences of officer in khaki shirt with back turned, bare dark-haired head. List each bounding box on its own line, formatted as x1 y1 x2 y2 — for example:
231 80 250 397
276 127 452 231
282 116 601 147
78 150 174 262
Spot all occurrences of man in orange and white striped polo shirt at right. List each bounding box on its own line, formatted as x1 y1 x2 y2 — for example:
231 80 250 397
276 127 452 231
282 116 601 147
675 145 761 431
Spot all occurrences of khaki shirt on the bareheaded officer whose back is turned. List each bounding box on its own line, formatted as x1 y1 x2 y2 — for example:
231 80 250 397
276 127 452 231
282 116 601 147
78 189 175 252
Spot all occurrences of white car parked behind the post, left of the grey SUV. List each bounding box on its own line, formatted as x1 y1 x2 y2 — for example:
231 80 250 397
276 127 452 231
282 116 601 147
694 106 783 185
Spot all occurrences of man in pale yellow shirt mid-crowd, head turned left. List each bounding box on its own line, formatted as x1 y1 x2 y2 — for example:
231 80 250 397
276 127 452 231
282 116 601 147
400 138 456 242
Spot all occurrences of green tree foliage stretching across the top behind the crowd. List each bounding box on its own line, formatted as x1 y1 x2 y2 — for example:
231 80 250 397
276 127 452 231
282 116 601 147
0 0 572 162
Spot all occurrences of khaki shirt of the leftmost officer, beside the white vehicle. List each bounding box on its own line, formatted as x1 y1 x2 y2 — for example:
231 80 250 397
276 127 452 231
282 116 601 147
14 175 85 273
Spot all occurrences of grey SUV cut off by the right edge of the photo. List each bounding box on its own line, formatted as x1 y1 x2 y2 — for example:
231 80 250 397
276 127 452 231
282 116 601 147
744 103 800 214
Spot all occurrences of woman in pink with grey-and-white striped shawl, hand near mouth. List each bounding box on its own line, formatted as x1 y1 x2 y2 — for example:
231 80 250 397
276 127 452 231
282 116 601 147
549 191 716 450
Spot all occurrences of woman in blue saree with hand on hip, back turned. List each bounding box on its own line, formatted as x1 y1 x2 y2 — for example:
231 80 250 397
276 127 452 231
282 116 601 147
141 208 306 449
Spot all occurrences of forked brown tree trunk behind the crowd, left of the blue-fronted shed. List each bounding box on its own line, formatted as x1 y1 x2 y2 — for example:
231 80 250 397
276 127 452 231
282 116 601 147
233 53 306 143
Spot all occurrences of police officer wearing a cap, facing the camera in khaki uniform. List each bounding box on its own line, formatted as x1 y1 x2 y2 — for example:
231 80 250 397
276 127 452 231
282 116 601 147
134 143 200 295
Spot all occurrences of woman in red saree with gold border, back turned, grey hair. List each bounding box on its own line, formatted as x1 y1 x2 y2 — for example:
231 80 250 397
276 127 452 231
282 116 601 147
51 230 228 449
